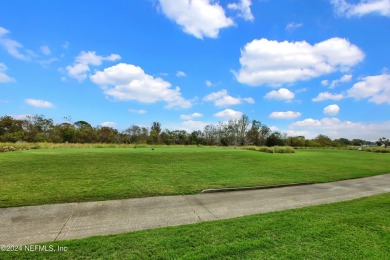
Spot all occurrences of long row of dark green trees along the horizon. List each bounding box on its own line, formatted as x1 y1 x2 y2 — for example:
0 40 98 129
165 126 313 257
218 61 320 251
0 115 390 147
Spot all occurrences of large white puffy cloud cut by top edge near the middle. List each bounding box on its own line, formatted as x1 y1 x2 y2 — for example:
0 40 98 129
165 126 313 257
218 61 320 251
159 0 234 39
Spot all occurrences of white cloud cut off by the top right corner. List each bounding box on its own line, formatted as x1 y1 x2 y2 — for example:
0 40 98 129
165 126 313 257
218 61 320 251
331 0 390 17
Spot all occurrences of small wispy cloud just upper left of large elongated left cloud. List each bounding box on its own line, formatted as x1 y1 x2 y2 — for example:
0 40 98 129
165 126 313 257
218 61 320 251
66 51 121 81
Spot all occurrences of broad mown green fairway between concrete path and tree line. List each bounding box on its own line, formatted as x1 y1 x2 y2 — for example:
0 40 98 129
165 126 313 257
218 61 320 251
0 147 390 207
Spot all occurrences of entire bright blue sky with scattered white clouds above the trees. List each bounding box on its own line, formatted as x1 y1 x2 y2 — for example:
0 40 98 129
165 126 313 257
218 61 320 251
0 0 390 140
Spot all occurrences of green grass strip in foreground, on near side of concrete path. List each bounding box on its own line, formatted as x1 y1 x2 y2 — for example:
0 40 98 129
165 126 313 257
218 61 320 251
0 193 390 259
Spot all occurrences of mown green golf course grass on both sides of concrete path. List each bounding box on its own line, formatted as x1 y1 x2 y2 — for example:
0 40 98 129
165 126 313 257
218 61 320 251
0 147 390 259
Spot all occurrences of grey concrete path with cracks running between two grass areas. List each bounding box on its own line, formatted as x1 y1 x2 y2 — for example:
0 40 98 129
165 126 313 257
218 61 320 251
0 174 390 245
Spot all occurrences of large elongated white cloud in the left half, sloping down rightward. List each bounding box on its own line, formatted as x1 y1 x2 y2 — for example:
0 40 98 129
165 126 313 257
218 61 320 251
90 63 192 108
